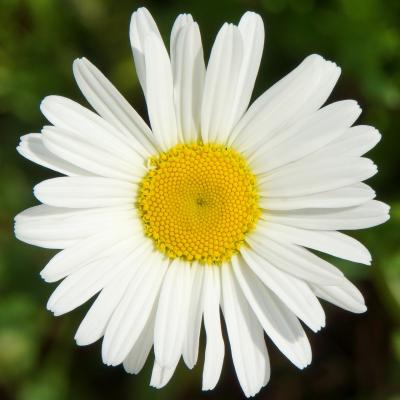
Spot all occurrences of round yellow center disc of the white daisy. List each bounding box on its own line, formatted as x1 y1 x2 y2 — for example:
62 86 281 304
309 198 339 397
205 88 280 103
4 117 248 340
136 143 260 264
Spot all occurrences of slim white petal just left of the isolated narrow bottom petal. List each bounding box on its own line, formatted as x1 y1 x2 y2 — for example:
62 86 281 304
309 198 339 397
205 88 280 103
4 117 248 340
182 262 205 369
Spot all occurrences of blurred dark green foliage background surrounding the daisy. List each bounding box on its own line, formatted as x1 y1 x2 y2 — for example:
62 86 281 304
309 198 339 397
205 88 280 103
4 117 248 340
0 0 400 400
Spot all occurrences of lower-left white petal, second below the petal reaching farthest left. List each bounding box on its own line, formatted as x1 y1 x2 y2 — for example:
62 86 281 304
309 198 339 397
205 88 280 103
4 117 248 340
47 242 132 315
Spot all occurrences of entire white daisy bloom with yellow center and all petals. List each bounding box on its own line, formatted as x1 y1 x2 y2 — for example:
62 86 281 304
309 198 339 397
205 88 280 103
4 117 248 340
15 8 388 396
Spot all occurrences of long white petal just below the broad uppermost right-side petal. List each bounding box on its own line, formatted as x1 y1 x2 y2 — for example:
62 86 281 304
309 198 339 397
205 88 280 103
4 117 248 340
249 100 361 174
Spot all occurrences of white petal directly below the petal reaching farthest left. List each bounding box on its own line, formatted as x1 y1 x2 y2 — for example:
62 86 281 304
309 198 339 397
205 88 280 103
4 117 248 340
40 221 142 282
